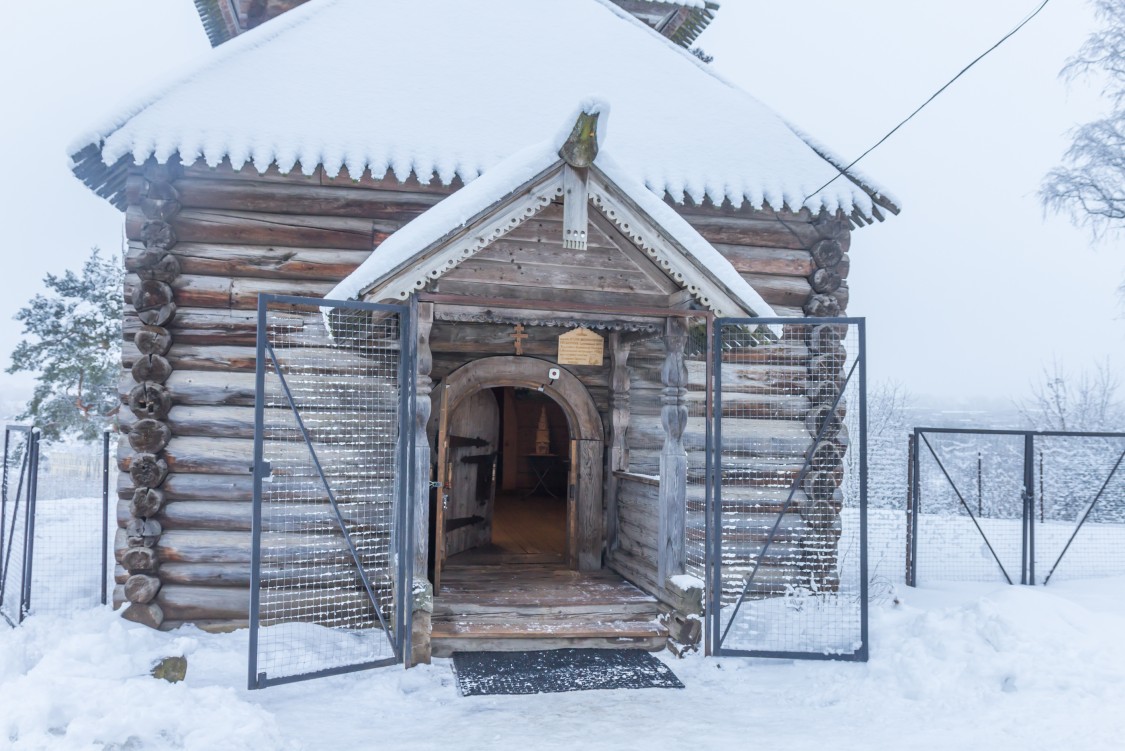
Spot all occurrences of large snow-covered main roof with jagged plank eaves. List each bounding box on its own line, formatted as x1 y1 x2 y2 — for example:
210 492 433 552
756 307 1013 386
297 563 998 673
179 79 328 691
71 0 897 222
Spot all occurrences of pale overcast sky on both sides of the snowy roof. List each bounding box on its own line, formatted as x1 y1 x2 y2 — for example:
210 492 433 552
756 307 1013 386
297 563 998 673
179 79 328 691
0 0 1125 413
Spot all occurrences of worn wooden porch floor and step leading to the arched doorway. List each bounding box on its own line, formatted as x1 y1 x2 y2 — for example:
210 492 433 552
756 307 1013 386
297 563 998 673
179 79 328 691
430 563 668 657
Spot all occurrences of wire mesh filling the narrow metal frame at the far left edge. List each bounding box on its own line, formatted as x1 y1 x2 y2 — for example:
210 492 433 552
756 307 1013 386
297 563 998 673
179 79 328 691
0 425 38 626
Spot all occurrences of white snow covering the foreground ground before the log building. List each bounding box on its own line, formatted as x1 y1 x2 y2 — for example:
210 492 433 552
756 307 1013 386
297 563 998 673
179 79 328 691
0 578 1125 751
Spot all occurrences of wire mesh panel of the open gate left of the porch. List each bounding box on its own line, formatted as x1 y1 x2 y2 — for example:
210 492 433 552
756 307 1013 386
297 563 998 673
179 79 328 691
250 296 413 688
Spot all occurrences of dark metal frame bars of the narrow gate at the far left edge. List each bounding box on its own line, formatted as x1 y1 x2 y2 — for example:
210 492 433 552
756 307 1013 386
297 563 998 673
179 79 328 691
0 425 39 626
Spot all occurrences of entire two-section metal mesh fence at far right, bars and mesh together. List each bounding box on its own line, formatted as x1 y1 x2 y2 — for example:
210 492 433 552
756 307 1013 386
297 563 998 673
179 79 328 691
908 427 1125 585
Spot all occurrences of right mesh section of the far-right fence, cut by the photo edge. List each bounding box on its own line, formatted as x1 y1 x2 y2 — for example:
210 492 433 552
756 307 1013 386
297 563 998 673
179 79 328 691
1031 435 1125 583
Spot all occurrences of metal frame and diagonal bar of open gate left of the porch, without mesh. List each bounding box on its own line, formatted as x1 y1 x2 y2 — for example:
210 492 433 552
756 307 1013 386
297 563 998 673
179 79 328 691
248 293 417 690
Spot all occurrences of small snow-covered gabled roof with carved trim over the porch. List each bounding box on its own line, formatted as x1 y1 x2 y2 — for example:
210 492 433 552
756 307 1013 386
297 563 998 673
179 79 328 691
325 100 776 317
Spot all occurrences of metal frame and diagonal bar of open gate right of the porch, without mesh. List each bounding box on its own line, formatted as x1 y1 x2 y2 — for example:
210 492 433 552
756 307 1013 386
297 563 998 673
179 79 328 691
705 317 870 662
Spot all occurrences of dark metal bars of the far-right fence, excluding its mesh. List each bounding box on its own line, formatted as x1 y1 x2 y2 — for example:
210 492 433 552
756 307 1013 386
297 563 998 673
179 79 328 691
907 427 1125 587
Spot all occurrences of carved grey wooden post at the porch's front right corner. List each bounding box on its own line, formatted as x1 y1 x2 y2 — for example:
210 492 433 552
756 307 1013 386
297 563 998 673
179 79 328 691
658 318 687 583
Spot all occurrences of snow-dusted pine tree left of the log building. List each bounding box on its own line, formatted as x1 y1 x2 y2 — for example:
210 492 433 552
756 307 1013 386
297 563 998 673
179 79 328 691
8 247 124 441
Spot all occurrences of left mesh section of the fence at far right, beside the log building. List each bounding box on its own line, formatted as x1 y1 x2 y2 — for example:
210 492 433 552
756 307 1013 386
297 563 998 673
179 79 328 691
911 429 1026 585
